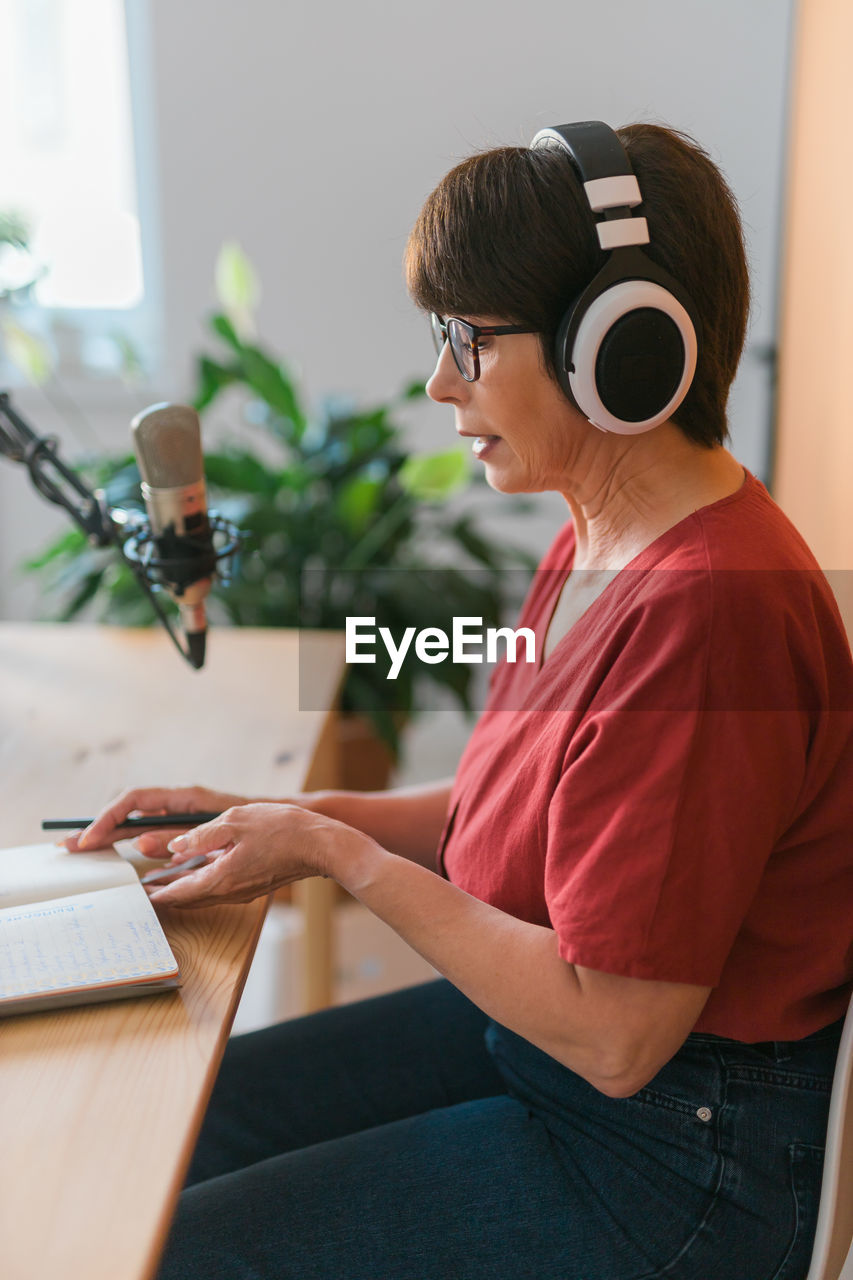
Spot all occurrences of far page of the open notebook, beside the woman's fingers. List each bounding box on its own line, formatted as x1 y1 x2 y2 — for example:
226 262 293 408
0 844 137 910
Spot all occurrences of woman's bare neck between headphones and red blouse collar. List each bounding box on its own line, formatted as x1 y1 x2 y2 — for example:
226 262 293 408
561 422 744 570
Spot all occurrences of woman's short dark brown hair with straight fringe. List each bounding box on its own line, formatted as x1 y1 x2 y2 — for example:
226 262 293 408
406 124 749 448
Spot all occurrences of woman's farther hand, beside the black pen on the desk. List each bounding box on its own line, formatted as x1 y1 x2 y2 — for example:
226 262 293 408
64 787 257 858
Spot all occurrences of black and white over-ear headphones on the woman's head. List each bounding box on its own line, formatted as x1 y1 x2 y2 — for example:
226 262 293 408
530 120 701 435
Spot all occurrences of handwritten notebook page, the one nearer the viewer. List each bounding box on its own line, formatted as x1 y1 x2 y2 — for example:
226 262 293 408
0 884 178 1010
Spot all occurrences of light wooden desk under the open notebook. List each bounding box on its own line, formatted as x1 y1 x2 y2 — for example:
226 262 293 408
0 623 343 1280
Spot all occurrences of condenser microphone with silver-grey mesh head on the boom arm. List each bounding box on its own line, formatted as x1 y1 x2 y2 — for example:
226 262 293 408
131 403 216 668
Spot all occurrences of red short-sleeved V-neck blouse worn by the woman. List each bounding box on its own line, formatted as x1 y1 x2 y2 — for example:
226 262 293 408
439 474 853 1041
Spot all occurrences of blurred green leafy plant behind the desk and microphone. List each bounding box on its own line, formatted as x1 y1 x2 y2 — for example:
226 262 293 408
27 248 533 758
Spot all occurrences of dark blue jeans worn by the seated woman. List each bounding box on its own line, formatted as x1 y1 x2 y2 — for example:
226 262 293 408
153 980 840 1280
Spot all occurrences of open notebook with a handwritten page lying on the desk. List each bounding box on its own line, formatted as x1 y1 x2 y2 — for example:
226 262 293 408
0 845 181 1016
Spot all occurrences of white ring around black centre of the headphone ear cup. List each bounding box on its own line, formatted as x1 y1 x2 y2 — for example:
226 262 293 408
557 279 698 435
